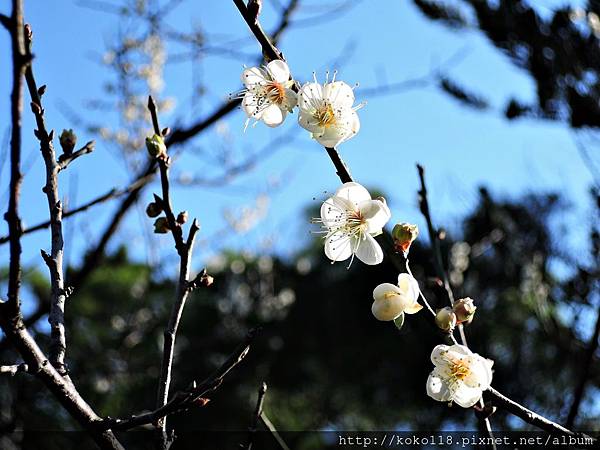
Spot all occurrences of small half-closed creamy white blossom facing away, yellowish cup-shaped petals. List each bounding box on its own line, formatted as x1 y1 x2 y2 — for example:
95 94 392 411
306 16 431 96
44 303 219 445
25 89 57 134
371 273 423 321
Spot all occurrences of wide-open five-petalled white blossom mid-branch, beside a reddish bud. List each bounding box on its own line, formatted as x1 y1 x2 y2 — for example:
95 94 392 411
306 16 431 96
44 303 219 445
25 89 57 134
315 182 391 267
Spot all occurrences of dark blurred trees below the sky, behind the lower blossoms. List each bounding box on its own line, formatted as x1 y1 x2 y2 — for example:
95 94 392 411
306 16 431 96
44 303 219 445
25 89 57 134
0 189 600 448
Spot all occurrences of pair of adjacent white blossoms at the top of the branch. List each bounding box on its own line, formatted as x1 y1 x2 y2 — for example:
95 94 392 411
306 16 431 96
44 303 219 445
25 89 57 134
239 60 362 147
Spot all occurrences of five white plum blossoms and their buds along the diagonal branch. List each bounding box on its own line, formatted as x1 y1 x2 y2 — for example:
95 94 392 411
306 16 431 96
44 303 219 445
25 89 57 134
237 60 493 408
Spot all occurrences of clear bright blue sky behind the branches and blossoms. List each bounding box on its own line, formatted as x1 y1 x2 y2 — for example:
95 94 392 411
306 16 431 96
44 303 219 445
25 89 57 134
0 0 592 282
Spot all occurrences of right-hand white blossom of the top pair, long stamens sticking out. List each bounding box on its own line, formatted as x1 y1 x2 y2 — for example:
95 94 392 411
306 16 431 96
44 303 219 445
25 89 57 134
298 74 362 147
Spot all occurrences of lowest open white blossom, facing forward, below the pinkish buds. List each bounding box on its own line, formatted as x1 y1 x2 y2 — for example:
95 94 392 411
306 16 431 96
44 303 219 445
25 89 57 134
427 344 494 408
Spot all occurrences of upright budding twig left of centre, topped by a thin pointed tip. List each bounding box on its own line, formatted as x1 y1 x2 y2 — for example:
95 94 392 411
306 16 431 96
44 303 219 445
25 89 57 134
148 96 200 449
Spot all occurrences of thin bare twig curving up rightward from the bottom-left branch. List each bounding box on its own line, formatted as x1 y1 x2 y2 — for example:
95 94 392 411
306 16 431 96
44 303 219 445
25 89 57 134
104 329 259 430
